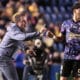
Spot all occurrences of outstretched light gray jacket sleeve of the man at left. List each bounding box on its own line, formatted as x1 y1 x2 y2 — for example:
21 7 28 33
9 31 40 40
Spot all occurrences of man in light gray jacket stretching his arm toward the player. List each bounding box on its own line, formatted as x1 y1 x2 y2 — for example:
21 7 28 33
0 12 40 80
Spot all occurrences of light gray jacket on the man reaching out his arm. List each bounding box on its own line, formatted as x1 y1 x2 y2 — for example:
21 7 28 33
0 25 40 58
